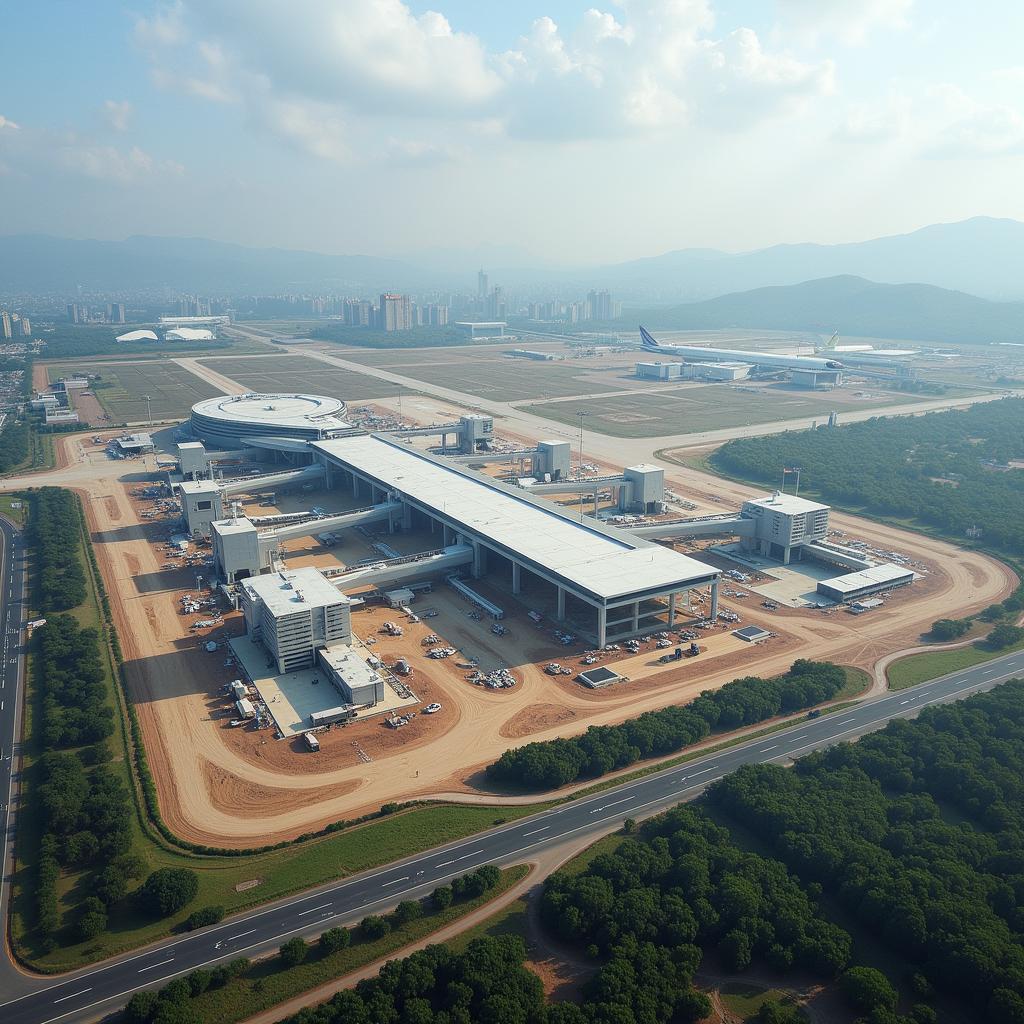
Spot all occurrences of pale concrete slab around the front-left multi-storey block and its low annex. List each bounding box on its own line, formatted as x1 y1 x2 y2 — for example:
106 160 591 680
230 637 420 737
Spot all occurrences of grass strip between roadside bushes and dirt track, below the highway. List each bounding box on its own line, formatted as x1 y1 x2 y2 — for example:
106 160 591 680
180 864 529 1024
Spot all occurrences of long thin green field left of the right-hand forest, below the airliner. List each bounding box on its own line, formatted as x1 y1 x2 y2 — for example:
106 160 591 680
525 384 920 437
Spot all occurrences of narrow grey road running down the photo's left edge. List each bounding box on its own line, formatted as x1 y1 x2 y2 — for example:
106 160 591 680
0 518 26 992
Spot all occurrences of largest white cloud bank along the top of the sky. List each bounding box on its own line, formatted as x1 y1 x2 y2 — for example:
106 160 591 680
136 0 834 155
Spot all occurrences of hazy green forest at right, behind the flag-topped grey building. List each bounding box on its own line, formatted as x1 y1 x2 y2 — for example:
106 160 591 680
713 398 1024 554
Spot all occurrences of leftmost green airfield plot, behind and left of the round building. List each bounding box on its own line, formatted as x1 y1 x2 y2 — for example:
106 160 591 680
46 359 221 423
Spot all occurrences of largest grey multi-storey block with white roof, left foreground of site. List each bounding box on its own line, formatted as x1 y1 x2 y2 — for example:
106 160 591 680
241 568 352 673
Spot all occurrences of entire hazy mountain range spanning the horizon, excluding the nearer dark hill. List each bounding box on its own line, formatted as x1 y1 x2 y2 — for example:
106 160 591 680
0 217 1024 306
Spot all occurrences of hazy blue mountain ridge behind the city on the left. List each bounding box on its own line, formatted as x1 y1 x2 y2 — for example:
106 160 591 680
0 234 425 295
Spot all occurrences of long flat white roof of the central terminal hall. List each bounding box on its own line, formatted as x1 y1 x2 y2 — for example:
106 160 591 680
311 434 718 602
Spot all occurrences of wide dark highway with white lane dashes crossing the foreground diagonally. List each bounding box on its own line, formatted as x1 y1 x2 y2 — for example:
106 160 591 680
0 651 1024 1024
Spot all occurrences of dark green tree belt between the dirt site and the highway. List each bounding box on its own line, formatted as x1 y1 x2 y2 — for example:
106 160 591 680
487 658 846 790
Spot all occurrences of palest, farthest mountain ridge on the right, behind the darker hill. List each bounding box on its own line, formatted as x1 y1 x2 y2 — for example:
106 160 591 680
593 217 1024 301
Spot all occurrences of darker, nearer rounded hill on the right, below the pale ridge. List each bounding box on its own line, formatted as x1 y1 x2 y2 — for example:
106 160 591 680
623 274 1024 344
